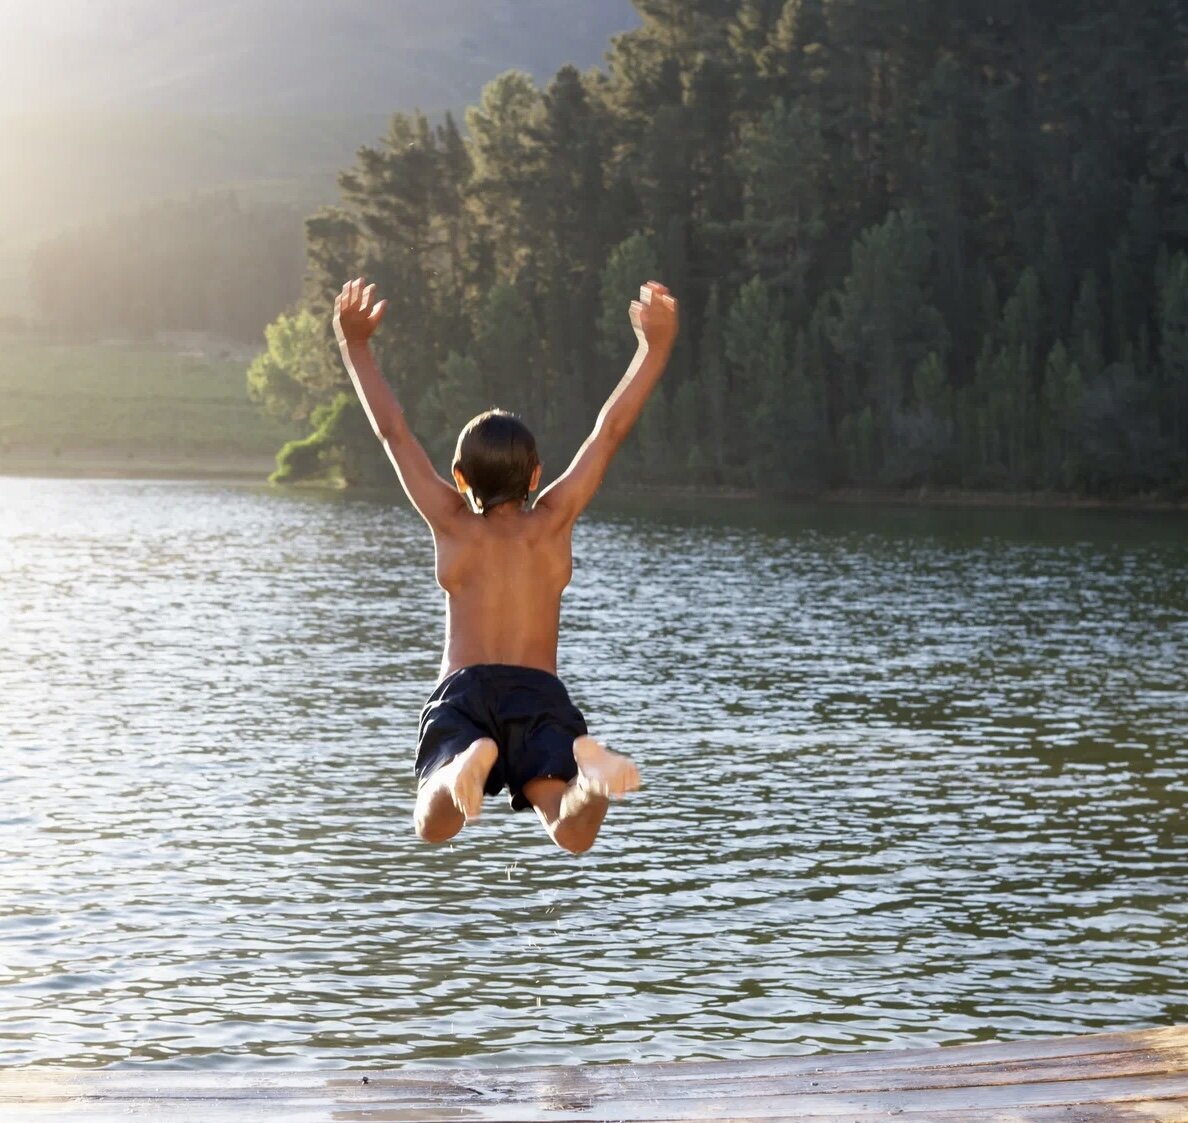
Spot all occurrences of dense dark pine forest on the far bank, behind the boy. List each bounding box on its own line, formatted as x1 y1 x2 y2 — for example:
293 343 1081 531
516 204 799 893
249 0 1188 496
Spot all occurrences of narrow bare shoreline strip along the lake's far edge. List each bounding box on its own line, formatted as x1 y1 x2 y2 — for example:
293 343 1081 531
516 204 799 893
0 454 1188 512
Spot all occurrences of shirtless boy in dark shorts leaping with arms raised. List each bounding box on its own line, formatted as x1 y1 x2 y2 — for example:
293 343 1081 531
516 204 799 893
334 278 677 853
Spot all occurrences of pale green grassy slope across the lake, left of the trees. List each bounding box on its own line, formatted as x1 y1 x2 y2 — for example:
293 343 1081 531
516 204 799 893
0 336 293 478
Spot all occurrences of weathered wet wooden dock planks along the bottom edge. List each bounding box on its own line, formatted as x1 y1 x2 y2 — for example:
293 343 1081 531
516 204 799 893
0 1026 1188 1123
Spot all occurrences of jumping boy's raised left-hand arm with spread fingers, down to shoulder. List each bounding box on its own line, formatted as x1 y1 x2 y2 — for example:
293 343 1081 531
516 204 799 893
334 277 466 530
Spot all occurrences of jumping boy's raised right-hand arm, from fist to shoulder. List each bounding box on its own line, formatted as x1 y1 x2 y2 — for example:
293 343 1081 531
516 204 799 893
536 280 677 519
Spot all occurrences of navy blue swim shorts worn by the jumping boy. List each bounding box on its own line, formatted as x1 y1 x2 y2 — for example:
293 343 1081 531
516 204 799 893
416 663 587 810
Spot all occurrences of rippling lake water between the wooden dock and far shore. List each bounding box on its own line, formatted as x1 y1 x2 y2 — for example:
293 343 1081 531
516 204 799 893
0 479 1188 1068
